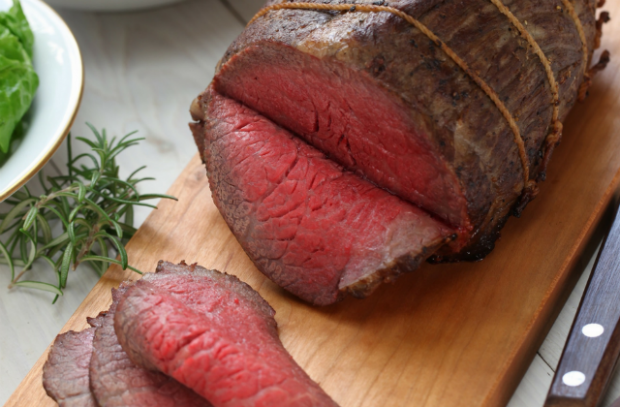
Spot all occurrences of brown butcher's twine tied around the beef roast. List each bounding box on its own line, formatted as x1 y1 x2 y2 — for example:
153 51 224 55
248 0 588 195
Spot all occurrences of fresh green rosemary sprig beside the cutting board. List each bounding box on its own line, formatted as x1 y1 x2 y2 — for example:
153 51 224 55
0 124 176 302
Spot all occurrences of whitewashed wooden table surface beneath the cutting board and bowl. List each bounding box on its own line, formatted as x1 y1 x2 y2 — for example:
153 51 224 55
0 0 620 407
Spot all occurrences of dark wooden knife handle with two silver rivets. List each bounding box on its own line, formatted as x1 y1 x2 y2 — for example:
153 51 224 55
545 207 620 407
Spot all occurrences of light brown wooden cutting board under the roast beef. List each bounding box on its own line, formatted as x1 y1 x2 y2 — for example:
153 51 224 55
6 8 620 407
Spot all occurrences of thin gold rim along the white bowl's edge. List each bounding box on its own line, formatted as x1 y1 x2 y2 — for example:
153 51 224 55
0 0 84 202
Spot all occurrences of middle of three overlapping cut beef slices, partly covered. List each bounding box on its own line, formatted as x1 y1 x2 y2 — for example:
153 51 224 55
89 284 211 407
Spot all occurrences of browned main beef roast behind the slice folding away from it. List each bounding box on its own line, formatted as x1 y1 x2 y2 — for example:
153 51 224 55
203 0 596 260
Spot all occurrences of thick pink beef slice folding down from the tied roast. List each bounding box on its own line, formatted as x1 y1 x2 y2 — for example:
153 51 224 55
195 88 454 305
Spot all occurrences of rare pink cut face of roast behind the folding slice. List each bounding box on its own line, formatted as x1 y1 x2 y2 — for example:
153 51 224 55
214 43 471 239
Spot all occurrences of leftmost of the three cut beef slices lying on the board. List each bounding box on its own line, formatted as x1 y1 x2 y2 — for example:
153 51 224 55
43 328 98 407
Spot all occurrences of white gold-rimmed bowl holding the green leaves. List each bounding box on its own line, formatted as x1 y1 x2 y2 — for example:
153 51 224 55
0 0 84 202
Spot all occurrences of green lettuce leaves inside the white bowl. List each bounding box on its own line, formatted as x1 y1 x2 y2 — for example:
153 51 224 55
0 0 39 153
